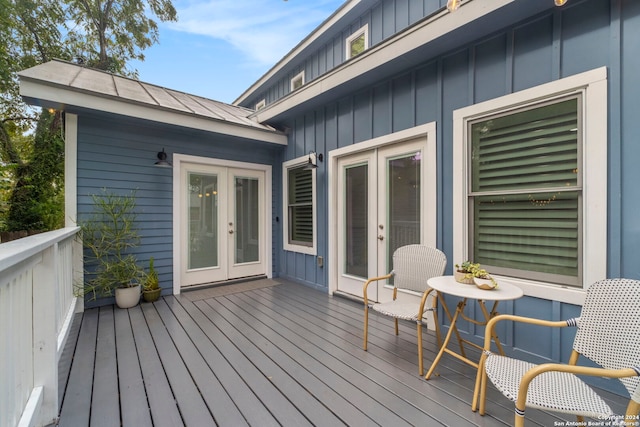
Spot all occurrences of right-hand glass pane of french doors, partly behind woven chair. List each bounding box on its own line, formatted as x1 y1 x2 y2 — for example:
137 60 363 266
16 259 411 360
385 152 421 270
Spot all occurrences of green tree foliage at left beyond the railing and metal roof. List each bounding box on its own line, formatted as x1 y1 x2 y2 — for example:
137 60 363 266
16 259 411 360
0 0 177 230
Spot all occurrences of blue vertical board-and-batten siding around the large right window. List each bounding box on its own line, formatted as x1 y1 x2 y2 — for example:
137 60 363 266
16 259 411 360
281 0 640 398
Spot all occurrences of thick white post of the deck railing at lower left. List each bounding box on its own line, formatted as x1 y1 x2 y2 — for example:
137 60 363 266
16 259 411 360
33 243 59 425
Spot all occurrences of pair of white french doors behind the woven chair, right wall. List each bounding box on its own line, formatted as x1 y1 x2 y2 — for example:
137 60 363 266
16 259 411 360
336 138 426 300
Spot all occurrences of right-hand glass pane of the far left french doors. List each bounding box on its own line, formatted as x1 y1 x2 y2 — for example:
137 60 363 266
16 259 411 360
234 178 260 264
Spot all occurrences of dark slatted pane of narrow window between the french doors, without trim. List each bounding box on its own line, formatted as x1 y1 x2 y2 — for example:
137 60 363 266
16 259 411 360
287 167 313 246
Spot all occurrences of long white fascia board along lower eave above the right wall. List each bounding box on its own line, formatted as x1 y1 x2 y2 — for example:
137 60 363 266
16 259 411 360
251 0 515 123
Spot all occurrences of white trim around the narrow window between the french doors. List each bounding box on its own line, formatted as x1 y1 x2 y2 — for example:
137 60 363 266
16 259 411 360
282 154 318 255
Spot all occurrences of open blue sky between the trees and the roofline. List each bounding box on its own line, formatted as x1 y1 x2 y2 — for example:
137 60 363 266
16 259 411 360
131 0 344 103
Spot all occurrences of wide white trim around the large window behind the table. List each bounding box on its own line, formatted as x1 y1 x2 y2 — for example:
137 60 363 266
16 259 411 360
452 67 608 305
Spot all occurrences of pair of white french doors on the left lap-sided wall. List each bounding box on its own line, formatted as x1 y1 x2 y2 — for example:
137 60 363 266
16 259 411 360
179 163 267 287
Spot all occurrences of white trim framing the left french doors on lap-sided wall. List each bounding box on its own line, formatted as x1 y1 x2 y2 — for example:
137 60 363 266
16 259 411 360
172 153 273 295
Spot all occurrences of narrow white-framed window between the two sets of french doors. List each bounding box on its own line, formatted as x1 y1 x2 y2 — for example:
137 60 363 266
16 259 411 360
283 156 316 255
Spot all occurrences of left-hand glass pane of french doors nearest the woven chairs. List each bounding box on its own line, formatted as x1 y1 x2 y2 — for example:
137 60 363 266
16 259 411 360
344 164 369 278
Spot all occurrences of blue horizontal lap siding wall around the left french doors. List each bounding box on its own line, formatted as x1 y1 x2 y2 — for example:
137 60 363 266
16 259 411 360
77 112 282 306
